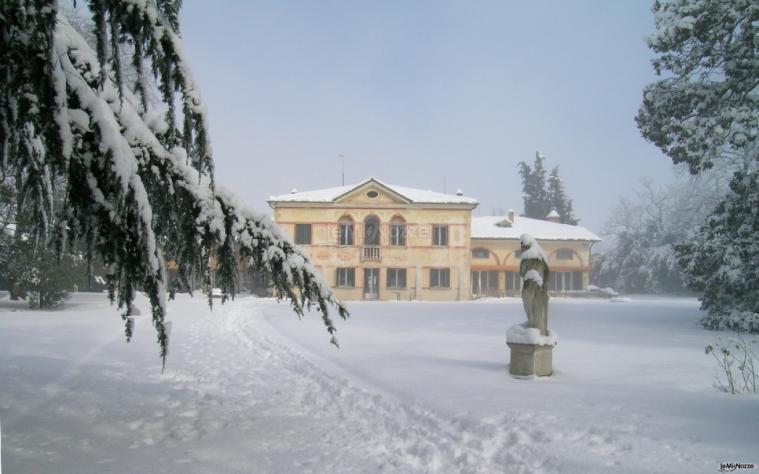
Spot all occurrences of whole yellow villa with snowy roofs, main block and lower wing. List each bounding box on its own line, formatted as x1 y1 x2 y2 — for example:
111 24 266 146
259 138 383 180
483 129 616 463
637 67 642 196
268 178 601 300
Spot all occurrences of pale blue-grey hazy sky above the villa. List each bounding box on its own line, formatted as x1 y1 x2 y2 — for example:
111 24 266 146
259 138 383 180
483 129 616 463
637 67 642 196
182 0 672 232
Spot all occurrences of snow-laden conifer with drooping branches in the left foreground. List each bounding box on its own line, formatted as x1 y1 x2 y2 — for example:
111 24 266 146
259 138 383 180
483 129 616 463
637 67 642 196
0 0 347 361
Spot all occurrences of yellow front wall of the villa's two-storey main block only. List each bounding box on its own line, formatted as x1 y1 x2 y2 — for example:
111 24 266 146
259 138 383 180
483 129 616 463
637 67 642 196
273 181 473 300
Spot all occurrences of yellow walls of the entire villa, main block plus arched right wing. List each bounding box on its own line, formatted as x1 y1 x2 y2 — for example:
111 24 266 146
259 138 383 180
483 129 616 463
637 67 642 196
271 183 590 300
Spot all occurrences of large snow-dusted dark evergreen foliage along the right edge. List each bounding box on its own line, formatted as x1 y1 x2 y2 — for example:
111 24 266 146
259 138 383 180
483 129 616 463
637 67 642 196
636 0 759 331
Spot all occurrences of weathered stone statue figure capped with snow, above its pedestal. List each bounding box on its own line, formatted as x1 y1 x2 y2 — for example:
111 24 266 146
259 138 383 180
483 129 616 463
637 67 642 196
519 234 550 336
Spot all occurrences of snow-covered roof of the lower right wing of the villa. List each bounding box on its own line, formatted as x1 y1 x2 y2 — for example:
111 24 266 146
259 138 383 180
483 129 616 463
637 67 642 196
472 216 601 242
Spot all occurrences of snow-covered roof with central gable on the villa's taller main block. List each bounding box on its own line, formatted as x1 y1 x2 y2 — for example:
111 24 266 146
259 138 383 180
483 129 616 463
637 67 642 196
268 177 478 205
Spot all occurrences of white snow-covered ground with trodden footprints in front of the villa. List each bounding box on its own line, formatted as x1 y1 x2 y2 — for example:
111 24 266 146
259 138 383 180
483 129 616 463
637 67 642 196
0 294 759 474
